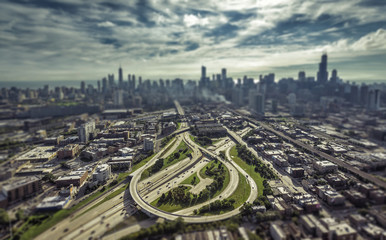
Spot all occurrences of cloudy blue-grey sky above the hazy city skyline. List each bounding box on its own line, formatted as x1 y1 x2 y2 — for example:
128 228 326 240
0 0 386 82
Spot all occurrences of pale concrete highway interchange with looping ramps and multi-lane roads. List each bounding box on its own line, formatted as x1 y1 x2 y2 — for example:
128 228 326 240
39 102 334 239
